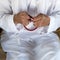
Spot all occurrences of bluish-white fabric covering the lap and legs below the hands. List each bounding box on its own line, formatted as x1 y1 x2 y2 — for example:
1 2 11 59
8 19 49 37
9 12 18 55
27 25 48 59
1 31 60 60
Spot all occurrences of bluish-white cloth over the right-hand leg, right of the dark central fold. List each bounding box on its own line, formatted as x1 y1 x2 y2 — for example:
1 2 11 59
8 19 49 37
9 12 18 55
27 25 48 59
34 33 60 60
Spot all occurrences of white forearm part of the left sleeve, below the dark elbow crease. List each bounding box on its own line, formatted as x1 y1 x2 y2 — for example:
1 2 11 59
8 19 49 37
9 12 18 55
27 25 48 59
1 15 17 32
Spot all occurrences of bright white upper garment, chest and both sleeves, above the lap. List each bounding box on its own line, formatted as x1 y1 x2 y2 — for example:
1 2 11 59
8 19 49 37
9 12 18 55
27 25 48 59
0 0 60 32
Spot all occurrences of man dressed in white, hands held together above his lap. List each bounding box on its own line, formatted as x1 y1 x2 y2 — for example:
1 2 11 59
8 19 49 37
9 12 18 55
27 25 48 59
0 0 60 60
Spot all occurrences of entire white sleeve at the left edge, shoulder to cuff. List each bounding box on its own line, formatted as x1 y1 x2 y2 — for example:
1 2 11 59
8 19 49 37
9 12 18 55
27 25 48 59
0 0 16 32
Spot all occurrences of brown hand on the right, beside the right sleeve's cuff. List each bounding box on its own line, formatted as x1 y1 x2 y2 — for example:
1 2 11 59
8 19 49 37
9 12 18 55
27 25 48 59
33 14 50 27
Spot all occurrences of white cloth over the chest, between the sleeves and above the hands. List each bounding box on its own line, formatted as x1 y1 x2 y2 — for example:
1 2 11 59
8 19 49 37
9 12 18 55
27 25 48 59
11 0 53 14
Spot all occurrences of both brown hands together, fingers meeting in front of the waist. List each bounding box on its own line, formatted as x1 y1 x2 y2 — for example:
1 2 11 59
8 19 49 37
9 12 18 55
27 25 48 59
14 11 50 27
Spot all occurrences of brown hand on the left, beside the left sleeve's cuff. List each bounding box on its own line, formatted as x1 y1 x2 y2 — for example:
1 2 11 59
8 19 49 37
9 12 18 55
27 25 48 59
14 12 30 26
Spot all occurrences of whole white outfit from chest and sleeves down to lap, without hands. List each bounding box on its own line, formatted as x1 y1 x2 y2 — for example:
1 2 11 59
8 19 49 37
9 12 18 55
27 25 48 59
0 0 60 60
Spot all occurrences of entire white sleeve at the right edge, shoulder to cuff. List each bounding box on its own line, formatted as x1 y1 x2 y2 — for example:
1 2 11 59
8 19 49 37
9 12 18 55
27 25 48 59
48 0 60 32
